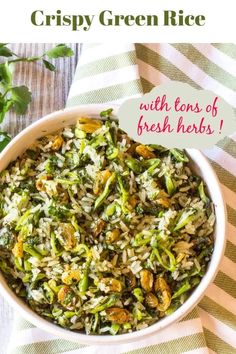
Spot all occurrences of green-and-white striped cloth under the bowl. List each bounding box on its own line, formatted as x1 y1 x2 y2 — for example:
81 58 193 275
9 44 236 354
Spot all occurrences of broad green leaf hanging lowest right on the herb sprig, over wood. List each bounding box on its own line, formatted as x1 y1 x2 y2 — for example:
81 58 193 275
11 86 31 114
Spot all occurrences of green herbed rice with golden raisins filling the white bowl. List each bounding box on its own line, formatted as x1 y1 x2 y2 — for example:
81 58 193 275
0 110 215 335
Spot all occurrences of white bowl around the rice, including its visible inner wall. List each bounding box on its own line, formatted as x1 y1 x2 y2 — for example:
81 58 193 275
0 105 226 345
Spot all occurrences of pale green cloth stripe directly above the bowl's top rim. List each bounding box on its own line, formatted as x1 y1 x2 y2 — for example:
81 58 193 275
67 80 141 107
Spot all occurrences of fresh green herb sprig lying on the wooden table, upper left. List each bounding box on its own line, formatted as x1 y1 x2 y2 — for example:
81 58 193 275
0 43 74 151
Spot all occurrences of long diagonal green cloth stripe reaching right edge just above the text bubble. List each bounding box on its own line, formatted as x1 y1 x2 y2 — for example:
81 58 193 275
172 44 236 91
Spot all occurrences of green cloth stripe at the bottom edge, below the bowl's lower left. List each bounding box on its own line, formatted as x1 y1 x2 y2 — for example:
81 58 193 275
11 339 85 354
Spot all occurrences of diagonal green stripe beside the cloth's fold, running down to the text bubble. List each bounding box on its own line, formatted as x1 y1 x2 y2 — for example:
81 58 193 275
136 43 200 88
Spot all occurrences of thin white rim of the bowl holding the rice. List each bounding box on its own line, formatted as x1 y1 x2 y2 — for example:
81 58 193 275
0 104 227 345
